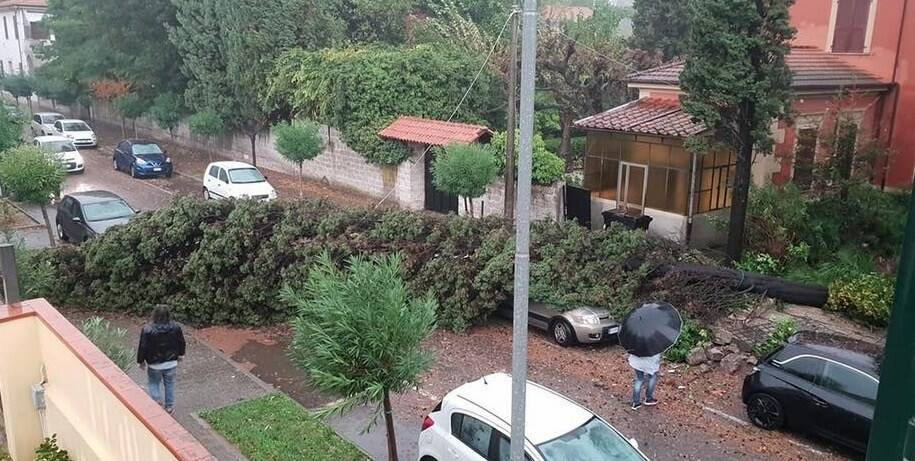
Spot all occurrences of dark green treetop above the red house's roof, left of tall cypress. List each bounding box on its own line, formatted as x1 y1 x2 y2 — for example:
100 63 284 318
632 0 691 61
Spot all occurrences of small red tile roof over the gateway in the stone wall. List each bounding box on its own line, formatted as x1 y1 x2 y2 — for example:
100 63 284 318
378 116 492 146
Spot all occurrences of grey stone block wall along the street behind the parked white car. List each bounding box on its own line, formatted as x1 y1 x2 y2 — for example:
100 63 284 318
84 104 425 210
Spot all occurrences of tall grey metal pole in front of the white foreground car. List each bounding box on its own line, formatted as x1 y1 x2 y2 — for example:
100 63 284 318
511 0 537 461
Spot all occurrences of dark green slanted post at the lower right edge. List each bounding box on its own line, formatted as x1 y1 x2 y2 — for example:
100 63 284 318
867 194 915 461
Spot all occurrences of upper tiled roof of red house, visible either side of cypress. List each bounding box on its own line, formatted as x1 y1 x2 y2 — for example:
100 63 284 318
629 47 889 90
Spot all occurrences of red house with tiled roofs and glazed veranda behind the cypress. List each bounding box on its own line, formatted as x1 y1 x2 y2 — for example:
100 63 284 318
576 0 915 245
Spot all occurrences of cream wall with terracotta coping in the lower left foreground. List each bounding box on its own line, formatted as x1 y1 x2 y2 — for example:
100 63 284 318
0 300 214 461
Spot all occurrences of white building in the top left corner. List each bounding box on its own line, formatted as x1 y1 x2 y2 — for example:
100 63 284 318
0 0 52 76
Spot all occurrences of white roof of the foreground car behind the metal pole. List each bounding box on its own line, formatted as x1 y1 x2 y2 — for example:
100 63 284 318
446 373 594 445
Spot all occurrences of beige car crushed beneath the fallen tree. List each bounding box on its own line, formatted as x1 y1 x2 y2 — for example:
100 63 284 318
499 303 620 347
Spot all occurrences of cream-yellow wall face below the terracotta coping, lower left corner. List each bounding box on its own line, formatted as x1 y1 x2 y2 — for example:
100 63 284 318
0 316 176 461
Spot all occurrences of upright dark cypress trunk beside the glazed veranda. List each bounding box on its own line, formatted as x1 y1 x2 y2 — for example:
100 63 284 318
728 107 756 262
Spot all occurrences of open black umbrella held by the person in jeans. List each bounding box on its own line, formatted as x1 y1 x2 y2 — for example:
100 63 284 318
619 303 683 357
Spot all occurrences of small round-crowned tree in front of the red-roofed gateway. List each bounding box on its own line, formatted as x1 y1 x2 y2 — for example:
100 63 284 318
432 144 499 217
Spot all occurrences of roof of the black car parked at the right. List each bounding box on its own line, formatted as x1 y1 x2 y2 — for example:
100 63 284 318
786 331 883 376
